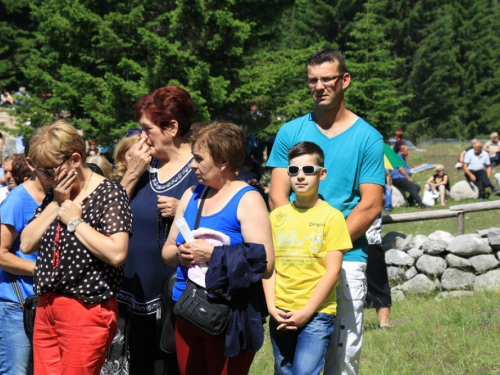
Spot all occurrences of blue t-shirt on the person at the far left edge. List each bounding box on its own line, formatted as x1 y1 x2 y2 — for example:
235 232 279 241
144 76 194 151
0 185 39 302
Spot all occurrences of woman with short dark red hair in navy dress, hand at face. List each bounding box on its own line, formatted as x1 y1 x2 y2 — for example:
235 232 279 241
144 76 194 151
110 86 198 374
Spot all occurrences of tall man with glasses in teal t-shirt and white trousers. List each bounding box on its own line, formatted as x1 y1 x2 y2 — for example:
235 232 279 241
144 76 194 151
267 49 385 375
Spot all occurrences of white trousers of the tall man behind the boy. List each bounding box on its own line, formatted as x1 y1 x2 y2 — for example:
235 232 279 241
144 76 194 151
324 262 366 375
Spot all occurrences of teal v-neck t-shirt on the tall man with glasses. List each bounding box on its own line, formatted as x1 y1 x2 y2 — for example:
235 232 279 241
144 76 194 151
267 113 385 262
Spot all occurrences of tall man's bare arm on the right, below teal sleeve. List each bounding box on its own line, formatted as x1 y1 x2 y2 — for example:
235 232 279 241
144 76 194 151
346 184 384 241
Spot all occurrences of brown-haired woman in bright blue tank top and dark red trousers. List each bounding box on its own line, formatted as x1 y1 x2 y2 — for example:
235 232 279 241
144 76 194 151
162 122 274 374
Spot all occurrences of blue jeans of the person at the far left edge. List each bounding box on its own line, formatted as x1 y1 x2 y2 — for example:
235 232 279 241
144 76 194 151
0 301 31 375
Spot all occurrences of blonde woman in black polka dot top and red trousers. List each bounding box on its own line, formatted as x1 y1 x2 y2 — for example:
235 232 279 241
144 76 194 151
21 121 132 374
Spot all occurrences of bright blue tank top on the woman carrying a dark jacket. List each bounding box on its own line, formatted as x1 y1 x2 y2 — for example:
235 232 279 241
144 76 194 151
172 184 257 301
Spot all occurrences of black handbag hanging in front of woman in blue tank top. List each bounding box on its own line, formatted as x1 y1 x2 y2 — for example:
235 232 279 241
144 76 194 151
174 280 230 336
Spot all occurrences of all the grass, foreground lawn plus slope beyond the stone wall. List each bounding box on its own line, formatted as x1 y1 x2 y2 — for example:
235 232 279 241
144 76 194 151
250 143 500 375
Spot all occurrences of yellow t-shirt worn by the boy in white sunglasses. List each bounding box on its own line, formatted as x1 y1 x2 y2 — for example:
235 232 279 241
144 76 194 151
271 202 352 315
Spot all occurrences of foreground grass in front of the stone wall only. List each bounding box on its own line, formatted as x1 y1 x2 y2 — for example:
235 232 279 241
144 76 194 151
250 291 500 375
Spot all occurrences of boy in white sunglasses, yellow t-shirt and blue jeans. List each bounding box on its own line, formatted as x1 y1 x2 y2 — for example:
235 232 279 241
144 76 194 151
266 142 352 375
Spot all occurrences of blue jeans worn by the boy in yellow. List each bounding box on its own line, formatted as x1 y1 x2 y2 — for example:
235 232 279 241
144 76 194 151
269 313 335 375
